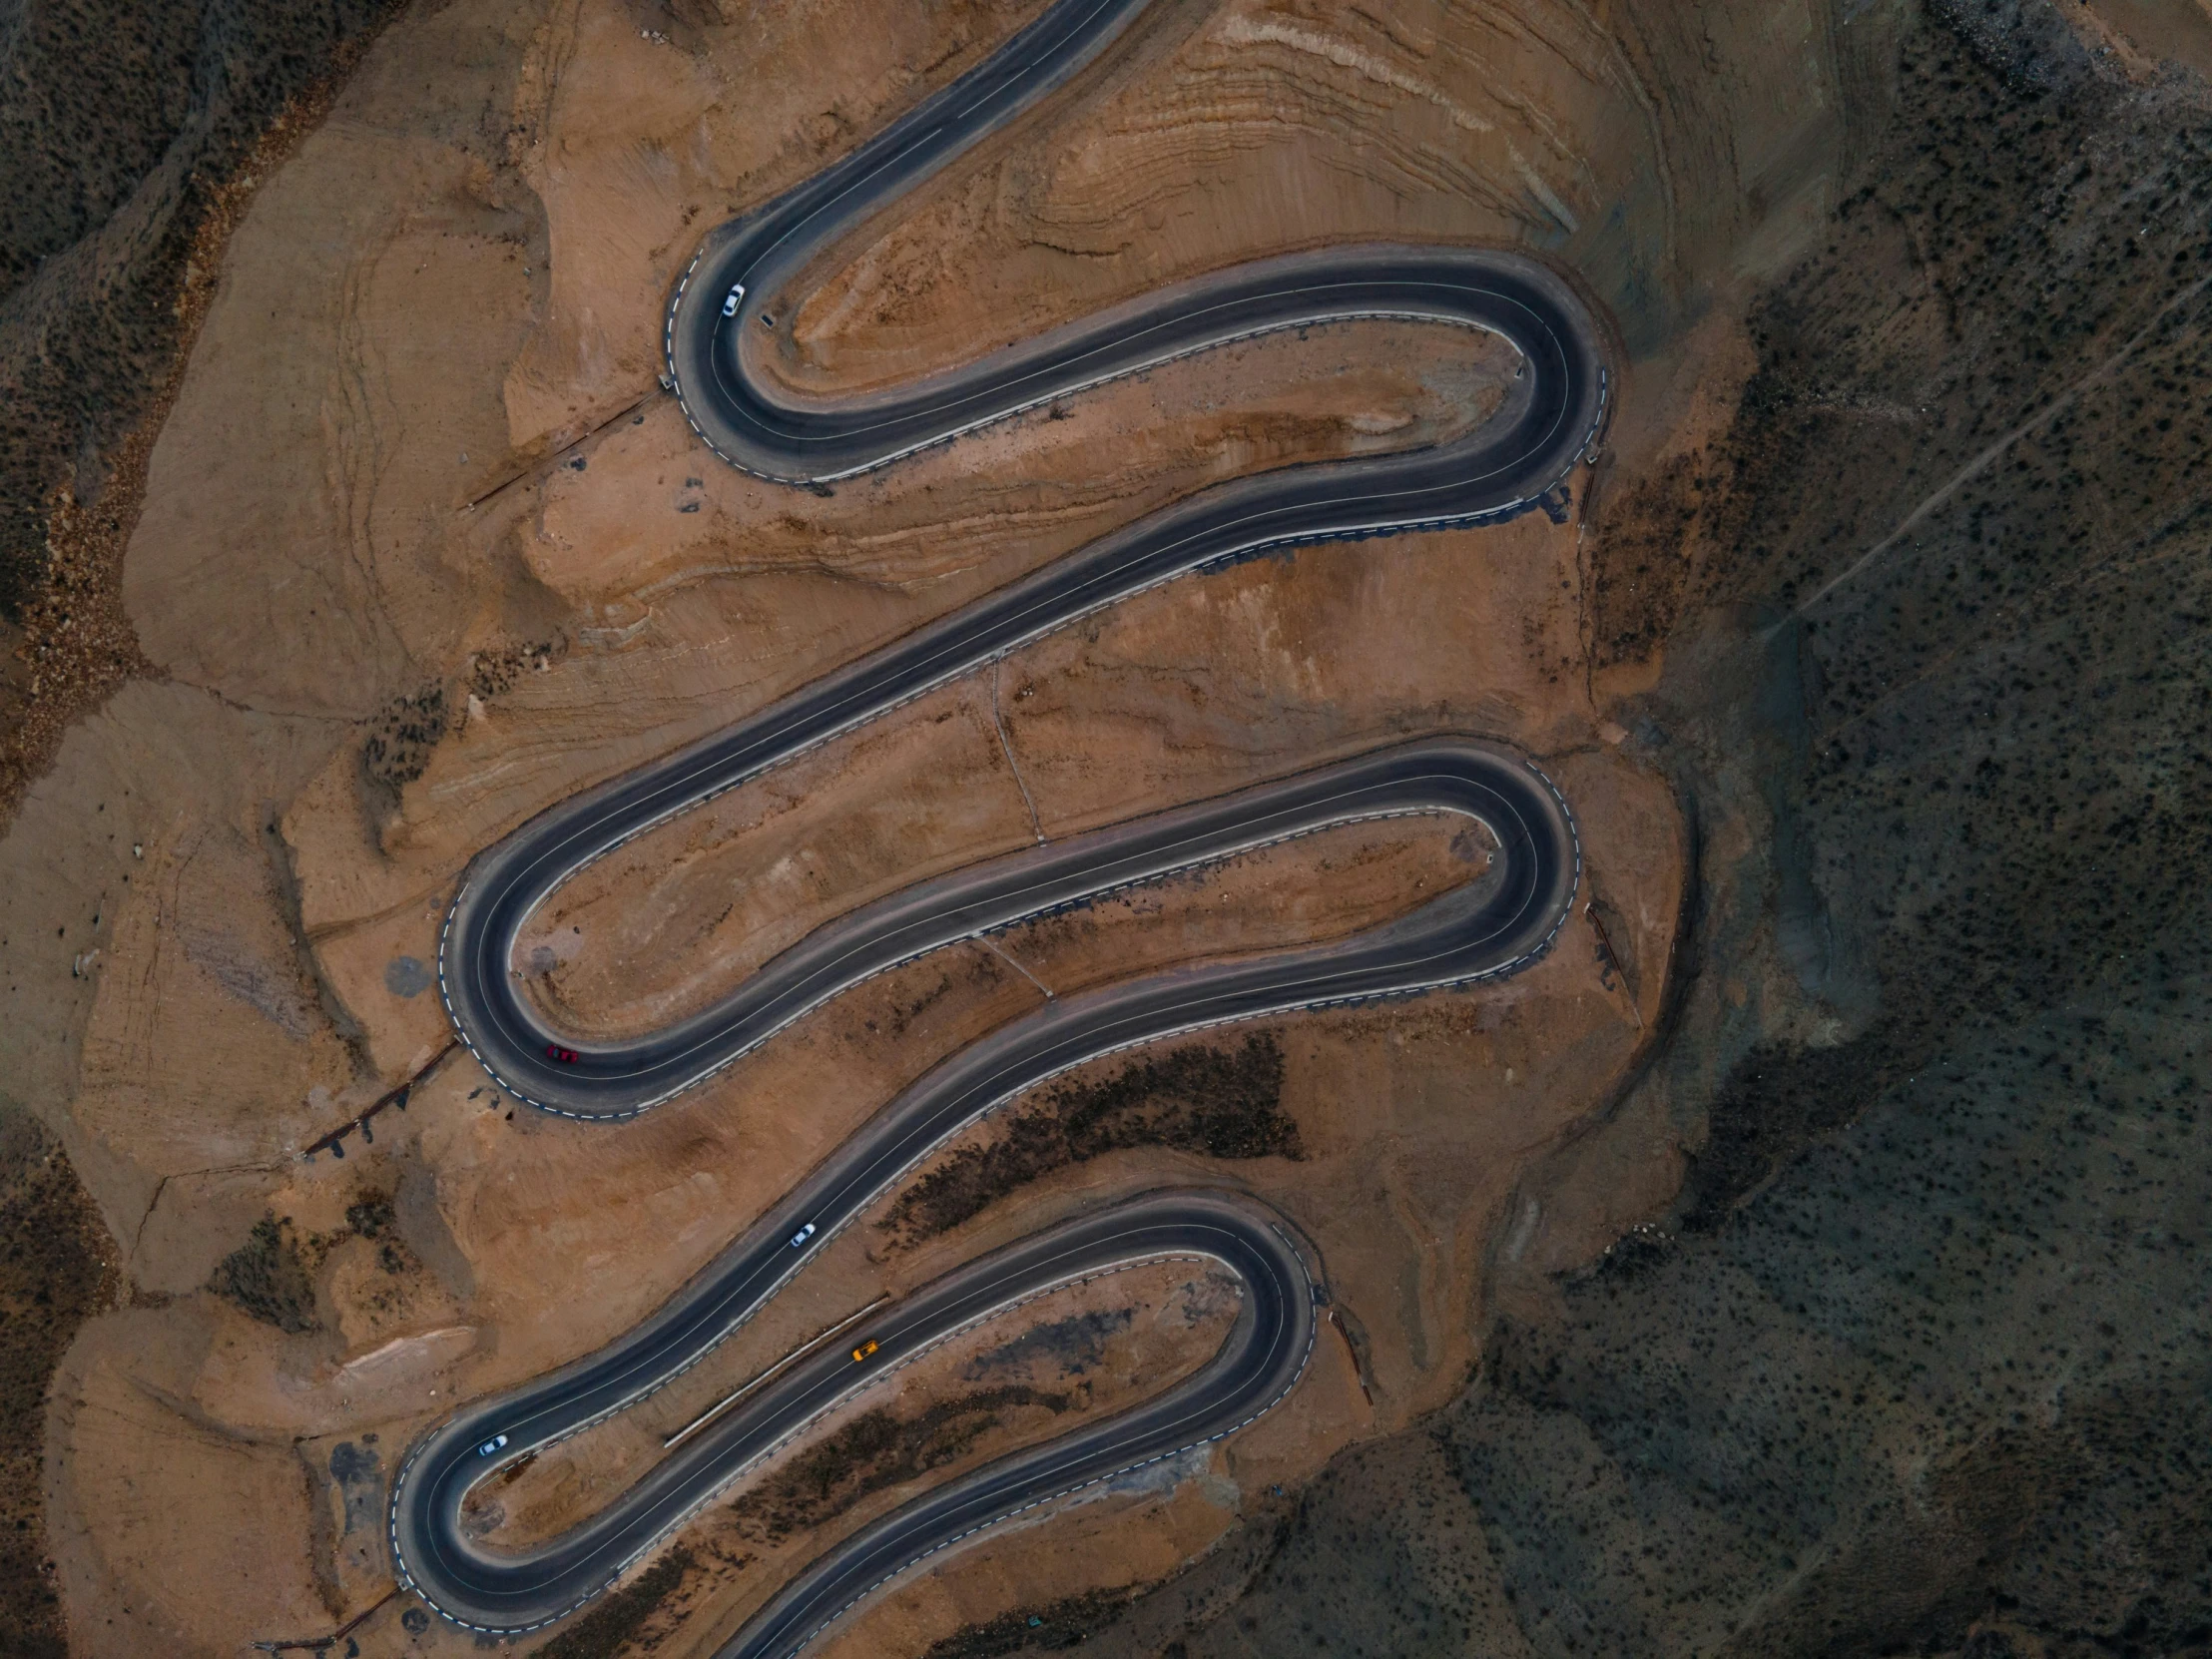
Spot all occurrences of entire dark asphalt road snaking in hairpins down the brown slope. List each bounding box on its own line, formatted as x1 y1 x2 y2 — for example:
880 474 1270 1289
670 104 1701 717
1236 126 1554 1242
389 0 1606 1659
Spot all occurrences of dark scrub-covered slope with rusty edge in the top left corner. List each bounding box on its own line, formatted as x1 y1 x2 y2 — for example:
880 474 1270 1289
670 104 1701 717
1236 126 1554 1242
0 0 400 817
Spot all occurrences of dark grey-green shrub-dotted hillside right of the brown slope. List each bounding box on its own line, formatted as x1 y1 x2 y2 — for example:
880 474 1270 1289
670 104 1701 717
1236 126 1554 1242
1039 11 2212 1657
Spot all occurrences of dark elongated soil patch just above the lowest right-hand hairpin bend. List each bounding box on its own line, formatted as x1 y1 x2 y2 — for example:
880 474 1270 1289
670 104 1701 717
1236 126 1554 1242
878 1031 1305 1246
